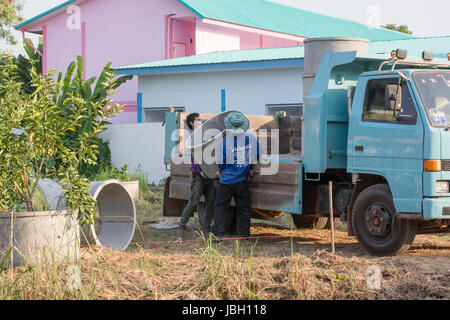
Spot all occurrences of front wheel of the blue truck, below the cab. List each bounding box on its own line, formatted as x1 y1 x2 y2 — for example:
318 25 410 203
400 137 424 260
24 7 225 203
352 184 417 257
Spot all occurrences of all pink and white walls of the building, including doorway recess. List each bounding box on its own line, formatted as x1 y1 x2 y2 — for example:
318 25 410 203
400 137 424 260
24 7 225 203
23 0 306 123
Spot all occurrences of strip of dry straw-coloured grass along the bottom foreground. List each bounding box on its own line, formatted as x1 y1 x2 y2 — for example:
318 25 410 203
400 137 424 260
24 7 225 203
0 244 384 300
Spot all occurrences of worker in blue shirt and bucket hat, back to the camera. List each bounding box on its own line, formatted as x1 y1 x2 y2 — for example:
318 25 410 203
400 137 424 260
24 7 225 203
213 112 262 240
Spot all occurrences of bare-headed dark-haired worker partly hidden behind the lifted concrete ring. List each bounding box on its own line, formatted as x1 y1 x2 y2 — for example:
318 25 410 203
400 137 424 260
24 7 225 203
176 113 216 242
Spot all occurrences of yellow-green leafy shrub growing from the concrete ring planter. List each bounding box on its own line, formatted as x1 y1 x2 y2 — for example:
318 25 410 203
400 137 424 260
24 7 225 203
0 56 130 223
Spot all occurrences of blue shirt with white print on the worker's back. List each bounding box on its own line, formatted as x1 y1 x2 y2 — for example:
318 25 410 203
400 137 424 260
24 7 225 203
217 132 263 184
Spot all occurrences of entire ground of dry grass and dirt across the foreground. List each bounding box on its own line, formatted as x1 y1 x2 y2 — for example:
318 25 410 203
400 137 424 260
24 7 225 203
0 188 450 300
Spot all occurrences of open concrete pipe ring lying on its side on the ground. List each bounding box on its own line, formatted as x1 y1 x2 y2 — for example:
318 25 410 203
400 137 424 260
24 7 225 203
81 180 136 251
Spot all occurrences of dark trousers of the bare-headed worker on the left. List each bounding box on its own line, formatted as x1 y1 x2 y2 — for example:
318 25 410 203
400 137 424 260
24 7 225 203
179 173 216 232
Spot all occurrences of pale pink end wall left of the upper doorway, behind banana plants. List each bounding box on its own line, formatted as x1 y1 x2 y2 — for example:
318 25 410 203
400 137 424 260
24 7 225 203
28 0 195 123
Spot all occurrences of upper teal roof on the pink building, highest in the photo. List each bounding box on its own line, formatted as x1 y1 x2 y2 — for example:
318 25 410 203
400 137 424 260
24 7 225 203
178 0 413 40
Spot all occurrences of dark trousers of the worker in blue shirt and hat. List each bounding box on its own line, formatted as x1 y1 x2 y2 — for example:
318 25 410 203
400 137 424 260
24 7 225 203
213 181 251 237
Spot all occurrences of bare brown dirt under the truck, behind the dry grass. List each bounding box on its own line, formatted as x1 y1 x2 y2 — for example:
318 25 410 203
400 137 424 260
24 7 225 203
134 212 450 300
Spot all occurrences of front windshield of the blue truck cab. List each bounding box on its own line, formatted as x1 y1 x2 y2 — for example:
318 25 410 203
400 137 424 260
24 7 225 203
414 71 450 127
